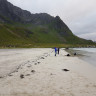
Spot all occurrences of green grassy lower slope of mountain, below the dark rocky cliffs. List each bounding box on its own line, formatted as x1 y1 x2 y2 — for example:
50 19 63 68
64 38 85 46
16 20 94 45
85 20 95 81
0 24 94 48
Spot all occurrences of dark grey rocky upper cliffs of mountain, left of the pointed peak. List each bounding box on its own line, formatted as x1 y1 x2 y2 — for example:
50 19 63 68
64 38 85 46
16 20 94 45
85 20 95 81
0 0 63 25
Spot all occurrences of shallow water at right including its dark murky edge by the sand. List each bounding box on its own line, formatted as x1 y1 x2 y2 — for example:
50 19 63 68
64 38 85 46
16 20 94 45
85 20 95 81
66 48 96 67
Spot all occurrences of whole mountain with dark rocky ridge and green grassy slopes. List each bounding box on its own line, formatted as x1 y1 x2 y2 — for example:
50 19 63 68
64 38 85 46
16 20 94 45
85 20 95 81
0 0 94 47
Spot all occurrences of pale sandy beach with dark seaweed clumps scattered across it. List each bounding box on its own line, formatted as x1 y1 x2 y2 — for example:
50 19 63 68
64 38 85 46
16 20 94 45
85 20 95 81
0 48 96 96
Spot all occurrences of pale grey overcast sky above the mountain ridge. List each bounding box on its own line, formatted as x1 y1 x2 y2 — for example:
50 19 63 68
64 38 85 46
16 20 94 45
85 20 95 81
8 0 96 41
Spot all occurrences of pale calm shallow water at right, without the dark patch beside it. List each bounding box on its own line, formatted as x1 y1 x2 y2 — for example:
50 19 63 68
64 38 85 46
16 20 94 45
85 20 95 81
72 48 96 67
